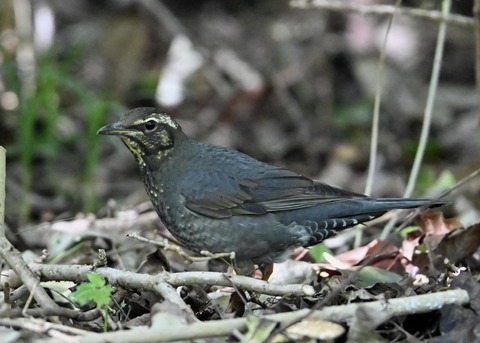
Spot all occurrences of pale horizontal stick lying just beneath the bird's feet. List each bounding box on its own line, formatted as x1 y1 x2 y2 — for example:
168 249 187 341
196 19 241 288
3 264 315 296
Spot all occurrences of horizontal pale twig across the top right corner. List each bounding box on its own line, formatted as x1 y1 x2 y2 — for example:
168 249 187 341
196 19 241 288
290 0 474 29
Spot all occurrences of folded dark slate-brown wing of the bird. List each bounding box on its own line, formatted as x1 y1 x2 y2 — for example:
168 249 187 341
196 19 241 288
183 166 364 218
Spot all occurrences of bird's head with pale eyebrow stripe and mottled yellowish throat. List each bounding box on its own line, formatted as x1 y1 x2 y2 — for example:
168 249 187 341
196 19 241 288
97 107 183 169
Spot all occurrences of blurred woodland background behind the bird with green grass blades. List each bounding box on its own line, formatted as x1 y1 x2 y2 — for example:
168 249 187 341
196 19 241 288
0 0 480 231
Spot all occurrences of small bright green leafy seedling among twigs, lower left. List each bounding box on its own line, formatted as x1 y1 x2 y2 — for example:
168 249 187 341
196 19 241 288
70 273 113 332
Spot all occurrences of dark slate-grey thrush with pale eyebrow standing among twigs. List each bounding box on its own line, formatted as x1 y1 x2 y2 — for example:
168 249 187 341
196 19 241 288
98 107 445 273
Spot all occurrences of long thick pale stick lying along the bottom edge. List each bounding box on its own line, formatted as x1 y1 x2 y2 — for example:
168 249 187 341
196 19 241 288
81 289 470 343
